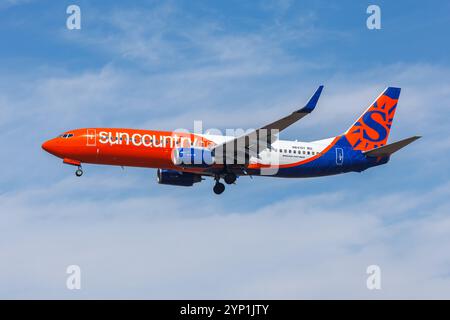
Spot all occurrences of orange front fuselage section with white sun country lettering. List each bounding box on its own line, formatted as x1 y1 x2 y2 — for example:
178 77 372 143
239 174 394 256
42 128 214 169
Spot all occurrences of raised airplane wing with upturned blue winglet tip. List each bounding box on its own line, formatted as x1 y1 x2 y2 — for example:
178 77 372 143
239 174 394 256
212 85 323 162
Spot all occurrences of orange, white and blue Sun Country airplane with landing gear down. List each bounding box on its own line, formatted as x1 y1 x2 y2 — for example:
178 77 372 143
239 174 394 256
42 85 420 194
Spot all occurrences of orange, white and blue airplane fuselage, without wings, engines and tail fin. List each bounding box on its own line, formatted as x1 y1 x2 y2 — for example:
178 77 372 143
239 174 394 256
43 128 386 178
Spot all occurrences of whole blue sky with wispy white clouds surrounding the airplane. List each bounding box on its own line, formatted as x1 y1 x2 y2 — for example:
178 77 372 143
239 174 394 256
0 0 450 299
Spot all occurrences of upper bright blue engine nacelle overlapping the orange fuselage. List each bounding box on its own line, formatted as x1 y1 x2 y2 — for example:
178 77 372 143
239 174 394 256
172 148 214 168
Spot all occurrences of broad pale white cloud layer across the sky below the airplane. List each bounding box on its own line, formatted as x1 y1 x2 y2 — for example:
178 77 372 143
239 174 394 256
0 180 450 298
